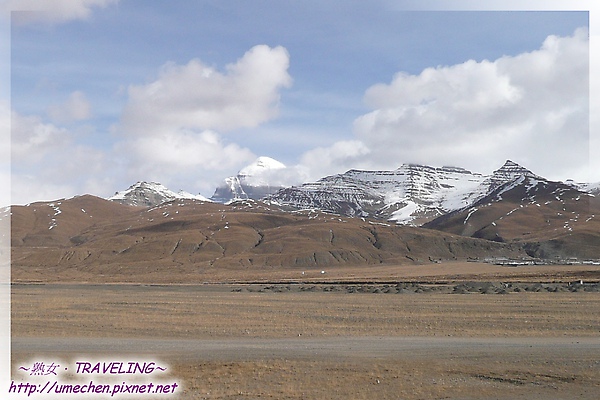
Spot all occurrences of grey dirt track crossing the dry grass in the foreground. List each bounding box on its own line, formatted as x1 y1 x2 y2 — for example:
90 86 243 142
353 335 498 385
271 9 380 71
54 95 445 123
12 336 600 362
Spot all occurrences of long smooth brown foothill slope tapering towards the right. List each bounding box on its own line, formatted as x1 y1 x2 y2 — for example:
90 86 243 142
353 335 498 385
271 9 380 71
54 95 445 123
12 196 525 282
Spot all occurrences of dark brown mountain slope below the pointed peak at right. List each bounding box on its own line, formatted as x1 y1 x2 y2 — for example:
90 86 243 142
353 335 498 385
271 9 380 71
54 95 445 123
424 175 600 258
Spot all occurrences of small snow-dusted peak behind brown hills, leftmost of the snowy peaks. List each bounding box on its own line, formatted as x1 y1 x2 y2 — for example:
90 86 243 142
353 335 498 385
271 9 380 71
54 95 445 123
108 182 210 207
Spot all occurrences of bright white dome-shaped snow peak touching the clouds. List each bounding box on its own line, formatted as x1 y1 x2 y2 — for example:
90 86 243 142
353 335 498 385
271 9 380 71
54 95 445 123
211 157 286 203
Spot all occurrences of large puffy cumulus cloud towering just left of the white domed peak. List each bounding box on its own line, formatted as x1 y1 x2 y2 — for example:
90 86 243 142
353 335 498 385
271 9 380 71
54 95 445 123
116 45 292 196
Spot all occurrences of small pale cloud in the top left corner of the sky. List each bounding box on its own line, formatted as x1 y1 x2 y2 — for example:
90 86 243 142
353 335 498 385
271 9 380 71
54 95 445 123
0 0 119 25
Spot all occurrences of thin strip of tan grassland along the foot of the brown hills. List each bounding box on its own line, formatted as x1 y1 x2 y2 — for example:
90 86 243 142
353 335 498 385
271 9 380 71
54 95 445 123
12 261 600 285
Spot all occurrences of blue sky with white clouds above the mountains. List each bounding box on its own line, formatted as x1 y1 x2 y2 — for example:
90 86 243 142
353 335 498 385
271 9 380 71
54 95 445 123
0 0 600 204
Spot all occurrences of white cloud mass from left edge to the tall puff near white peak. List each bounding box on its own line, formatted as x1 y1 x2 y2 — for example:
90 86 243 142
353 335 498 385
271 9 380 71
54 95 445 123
6 46 291 204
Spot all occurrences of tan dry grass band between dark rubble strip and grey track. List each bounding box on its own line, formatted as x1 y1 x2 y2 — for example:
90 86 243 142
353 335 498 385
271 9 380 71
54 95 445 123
12 285 600 339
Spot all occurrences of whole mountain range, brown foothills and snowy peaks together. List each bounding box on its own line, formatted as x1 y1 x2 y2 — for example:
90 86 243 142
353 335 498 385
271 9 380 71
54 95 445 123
9 159 600 282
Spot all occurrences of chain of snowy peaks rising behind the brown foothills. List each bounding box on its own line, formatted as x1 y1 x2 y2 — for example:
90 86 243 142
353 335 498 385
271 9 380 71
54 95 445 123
109 157 600 226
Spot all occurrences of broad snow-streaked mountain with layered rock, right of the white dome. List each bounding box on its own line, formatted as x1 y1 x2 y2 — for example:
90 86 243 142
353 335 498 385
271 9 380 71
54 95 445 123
269 160 580 225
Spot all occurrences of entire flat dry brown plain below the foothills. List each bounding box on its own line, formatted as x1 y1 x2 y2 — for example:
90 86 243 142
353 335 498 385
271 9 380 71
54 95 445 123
12 263 600 399
